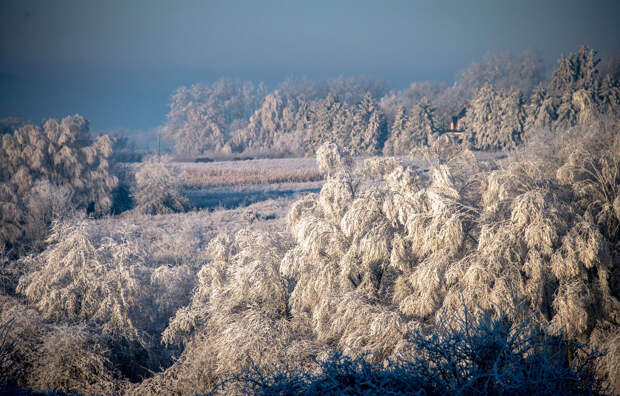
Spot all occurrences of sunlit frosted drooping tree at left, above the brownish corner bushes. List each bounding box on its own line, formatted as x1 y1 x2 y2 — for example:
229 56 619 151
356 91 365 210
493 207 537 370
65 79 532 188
17 218 194 381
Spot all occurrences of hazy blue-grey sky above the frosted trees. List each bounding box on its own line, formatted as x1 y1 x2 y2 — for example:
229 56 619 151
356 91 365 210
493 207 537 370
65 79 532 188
0 0 620 132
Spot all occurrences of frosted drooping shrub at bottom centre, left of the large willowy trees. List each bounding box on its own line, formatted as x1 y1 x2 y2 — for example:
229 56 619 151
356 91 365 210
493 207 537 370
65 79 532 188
138 230 321 394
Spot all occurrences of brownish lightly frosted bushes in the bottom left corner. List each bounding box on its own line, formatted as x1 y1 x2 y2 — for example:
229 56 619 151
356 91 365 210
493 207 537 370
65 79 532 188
0 297 124 394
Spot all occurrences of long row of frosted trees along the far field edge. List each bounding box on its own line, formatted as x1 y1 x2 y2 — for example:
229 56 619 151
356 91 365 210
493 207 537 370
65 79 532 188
163 46 620 156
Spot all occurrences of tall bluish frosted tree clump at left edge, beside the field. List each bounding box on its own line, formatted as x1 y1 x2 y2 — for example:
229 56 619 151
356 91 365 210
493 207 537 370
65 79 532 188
0 115 118 251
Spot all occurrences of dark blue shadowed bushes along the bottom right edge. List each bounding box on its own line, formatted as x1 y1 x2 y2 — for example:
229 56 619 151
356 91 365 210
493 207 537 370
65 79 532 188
228 311 606 395
